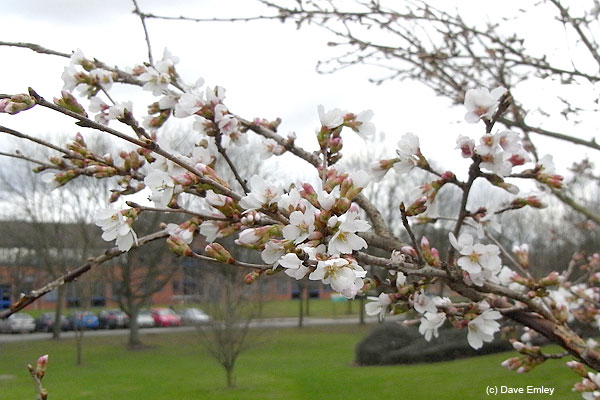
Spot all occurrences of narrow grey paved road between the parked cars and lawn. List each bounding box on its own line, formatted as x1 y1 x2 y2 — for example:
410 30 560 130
0 317 394 343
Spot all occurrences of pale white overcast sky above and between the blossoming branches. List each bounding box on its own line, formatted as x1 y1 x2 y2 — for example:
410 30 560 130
0 0 598 184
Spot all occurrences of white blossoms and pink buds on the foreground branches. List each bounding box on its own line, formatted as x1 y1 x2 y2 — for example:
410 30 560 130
5 43 600 399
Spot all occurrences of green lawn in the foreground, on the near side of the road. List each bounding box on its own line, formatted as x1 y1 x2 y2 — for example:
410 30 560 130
0 326 581 400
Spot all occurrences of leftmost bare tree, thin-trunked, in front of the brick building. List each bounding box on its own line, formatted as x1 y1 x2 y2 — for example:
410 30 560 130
0 158 108 339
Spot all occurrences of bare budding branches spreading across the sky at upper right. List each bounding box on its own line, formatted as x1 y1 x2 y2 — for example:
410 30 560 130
157 0 600 225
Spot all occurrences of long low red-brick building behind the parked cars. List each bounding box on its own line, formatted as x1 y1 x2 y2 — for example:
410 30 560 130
0 221 331 310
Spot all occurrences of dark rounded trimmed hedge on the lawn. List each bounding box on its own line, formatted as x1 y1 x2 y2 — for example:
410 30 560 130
356 323 512 365
